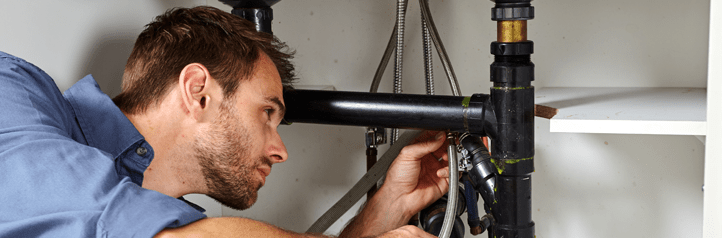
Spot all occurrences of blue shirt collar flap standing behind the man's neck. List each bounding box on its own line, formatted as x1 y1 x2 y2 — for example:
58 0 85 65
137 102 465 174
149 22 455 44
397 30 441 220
64 75 145 162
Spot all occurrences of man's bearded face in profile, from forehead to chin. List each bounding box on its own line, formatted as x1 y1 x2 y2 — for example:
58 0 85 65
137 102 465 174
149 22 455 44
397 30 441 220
194 54 288 210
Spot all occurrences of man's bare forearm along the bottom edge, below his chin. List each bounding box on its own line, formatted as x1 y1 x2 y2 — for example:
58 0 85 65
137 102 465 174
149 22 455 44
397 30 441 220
155 217 328 238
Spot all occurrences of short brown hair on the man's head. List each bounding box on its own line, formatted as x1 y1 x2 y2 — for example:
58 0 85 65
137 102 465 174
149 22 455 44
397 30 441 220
113 6 294 114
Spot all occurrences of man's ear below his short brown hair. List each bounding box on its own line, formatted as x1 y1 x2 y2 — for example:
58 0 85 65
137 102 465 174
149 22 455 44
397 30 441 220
178 63 221 121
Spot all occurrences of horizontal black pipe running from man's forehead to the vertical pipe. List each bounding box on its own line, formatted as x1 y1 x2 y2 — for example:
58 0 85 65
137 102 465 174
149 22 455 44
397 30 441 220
283 90 496 136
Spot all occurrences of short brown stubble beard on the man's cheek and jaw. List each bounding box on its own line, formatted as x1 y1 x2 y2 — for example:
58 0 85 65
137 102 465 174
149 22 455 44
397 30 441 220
194 101 271 210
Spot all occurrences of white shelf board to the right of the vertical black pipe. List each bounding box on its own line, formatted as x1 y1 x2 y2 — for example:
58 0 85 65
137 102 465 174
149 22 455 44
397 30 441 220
535 88 707 135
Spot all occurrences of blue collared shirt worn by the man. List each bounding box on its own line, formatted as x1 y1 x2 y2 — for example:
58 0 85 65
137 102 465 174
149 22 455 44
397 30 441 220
0 52 205 237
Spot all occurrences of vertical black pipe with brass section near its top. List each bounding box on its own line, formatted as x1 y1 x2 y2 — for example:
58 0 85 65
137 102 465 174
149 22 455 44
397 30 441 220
489 0 534 238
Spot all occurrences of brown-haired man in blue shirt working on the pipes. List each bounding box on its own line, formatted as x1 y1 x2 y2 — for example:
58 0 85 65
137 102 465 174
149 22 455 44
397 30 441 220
0 7 448 237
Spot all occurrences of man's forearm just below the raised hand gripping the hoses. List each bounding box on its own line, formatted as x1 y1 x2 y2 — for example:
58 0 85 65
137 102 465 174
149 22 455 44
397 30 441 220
339 187 412 238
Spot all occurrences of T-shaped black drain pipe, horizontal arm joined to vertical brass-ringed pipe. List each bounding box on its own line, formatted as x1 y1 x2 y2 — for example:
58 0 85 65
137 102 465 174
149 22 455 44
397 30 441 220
284 0 535 235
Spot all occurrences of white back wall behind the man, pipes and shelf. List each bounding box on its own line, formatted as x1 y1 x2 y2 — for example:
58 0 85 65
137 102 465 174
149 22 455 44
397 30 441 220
0 0 709 238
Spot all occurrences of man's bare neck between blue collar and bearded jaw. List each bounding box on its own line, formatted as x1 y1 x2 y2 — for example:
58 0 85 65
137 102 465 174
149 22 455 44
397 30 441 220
126 109 206 198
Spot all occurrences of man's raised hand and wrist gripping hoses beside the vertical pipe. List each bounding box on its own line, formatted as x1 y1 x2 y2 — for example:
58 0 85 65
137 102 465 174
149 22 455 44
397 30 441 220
339 132 449 237
